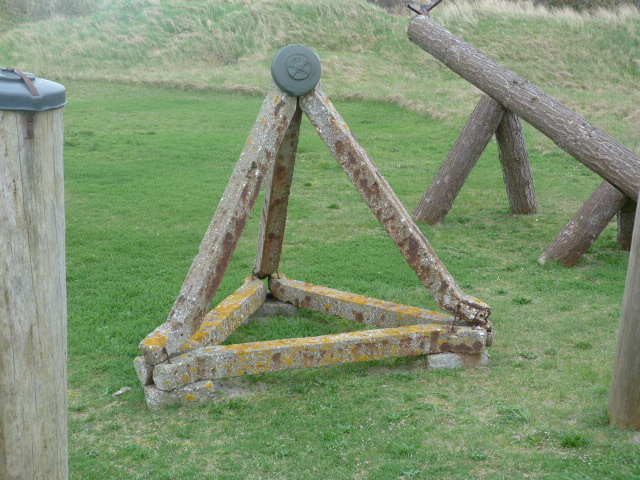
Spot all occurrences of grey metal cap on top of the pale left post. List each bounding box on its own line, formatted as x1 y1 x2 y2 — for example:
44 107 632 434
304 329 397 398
0 67 67 112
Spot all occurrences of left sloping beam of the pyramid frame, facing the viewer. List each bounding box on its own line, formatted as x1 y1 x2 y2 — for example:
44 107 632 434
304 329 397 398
140 88 297 365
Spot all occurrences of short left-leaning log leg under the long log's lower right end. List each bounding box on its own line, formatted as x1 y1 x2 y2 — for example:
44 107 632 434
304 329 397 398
539 182 627 267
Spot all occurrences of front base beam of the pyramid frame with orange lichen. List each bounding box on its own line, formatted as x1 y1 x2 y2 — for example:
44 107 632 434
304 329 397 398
153 325 486 391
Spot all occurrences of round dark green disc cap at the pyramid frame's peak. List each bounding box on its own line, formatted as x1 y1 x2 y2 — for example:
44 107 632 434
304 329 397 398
271 45 322 96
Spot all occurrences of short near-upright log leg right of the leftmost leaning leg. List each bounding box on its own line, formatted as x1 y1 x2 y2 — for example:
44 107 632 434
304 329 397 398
496 111 538 215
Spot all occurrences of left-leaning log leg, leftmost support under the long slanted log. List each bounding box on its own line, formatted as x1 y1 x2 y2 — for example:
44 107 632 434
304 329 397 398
413 95 504 225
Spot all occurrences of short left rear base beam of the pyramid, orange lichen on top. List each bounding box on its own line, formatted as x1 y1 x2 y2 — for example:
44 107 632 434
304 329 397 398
178 277 267 354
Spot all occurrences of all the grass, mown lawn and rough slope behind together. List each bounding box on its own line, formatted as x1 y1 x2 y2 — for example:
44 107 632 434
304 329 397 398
0 0 640 480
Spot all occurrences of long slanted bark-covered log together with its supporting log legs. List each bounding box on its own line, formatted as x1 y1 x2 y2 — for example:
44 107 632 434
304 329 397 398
409 15 640 266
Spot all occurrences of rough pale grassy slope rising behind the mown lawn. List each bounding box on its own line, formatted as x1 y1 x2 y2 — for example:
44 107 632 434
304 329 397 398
0 0 640 149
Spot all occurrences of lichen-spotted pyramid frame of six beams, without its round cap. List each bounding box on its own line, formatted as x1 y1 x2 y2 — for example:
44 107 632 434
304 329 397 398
135 85 492 407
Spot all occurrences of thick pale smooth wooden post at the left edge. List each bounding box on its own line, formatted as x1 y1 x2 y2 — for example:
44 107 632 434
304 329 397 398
0 69 68 480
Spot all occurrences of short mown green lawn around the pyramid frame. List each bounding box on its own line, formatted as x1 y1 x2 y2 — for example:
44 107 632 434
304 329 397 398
65 81 640 480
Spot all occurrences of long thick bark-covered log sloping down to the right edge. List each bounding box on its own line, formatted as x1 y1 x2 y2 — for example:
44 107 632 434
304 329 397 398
409 15 640 201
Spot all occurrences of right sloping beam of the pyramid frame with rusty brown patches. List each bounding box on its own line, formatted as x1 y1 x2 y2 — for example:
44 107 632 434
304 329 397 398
299 86 491 325
